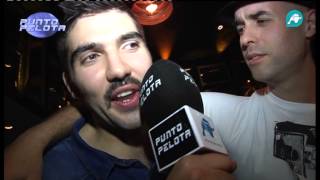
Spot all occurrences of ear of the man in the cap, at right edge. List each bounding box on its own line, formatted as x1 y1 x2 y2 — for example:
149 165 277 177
304 9 316 38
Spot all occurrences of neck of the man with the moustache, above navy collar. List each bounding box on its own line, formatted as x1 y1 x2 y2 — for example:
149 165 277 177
79 123 149 167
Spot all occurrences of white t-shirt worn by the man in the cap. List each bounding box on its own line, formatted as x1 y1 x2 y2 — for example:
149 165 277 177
201 92 316 180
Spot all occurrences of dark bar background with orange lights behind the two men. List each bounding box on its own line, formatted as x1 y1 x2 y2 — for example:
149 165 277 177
3 0 257 145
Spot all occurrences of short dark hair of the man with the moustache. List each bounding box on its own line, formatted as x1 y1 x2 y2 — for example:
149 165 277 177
57 1 145 73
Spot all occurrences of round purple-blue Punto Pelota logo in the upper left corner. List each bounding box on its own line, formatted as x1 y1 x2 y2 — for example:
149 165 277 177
19 12 66 38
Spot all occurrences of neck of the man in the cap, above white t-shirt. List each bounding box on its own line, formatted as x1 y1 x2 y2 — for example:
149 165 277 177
268 54 316 103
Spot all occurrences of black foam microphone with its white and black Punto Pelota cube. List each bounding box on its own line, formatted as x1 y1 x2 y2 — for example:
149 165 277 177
139 60 227 172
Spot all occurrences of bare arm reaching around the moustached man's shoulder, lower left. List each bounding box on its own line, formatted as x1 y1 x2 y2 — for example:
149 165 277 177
4 106 81 180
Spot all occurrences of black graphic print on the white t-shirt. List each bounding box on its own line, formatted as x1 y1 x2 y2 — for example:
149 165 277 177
273 121 316 178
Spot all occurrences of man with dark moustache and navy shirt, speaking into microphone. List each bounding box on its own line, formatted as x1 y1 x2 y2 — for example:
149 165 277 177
43 2 152 179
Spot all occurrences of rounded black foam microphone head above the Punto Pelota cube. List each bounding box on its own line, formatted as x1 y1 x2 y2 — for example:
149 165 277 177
139 60 203 129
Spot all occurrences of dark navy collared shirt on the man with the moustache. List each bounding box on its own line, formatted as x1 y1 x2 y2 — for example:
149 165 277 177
43 118 149 180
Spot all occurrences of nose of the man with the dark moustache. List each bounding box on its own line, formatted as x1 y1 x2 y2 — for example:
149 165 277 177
106 54 131 82
